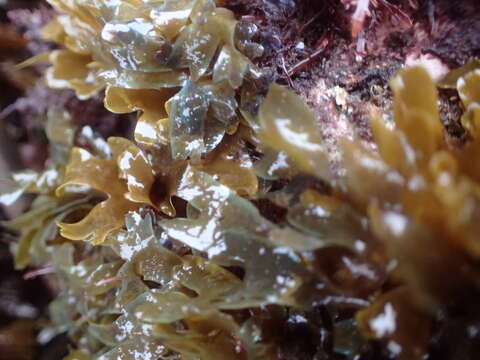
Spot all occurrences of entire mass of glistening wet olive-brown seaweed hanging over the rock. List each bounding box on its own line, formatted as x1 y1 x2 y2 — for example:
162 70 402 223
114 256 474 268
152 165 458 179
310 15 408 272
2 0 480 359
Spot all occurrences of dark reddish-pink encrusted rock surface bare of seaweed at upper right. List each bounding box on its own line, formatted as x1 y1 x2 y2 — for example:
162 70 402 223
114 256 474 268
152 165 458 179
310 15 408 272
226 0 480 174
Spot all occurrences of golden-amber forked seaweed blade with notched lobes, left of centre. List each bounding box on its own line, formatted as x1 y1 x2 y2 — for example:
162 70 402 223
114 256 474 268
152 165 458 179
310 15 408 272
57 138 158 244
